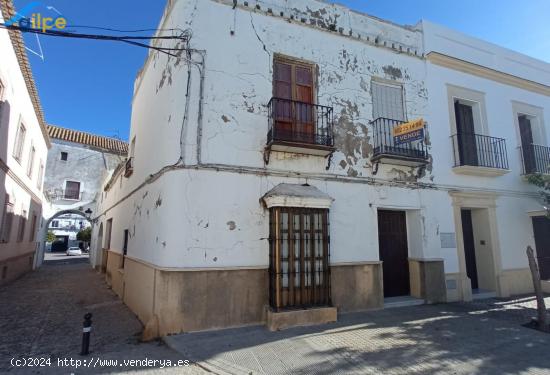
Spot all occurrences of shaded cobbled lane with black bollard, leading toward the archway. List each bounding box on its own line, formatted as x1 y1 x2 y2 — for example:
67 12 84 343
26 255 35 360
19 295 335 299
0 258 207 374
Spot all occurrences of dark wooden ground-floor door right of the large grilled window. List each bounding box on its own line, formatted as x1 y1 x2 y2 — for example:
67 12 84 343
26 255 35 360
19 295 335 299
378 210 410 297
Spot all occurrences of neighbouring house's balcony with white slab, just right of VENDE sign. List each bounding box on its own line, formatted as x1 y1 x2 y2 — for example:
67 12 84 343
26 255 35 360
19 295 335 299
451 133 510 177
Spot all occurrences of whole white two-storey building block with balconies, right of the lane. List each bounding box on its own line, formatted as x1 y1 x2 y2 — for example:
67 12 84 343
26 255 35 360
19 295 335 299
92 0 550 335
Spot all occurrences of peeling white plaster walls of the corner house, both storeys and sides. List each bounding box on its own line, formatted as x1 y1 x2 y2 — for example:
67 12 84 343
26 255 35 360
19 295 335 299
95 1 448 267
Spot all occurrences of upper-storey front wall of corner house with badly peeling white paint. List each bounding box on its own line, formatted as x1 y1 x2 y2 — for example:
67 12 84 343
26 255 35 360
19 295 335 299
193 1 427 178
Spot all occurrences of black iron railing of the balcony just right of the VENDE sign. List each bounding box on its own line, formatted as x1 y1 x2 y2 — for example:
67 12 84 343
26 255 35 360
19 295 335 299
451 133 508 169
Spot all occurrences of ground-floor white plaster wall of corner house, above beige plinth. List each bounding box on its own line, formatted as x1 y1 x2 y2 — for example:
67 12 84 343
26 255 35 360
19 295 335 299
96 170 457 272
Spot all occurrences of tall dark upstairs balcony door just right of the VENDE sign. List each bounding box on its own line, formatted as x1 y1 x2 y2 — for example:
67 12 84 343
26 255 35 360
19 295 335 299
455 101 478 166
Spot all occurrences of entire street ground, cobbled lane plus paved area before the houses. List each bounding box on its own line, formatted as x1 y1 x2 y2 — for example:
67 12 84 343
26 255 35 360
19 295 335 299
0 256 550 375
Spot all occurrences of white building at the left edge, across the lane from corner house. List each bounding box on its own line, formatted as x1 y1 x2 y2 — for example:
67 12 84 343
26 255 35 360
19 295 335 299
0 0 50 284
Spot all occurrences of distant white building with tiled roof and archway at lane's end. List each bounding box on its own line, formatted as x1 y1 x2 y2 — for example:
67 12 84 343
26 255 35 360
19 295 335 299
44 125 128 251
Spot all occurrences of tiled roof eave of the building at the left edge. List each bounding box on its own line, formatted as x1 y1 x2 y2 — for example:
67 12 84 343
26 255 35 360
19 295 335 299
0 0 51 148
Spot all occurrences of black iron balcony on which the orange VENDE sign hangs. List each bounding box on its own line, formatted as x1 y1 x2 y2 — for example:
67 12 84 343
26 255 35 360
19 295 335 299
371 117 429 166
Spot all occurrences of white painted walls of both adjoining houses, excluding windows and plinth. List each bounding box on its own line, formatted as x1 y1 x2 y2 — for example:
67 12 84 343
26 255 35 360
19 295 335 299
91 0 550 312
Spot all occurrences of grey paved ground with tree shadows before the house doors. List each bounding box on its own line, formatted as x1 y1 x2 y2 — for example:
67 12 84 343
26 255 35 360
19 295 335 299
165 298 550 375
